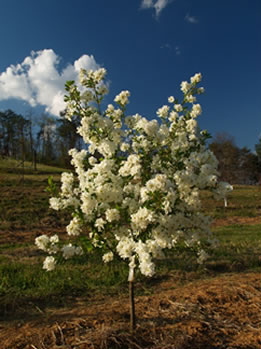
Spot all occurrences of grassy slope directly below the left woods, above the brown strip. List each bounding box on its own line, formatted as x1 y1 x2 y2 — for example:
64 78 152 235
0 159 68 231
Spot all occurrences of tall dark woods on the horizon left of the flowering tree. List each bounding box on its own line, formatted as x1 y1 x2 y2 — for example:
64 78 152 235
0 109 81 167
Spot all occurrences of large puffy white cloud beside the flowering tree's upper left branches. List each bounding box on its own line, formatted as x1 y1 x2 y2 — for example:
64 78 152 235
0 49 100 116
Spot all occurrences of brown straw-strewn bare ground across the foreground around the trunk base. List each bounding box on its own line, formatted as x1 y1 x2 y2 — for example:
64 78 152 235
0 273 261 349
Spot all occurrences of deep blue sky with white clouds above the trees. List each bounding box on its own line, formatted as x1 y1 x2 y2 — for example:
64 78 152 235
0 0 261 150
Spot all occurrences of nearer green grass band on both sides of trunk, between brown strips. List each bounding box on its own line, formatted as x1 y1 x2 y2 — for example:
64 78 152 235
0 224 261 315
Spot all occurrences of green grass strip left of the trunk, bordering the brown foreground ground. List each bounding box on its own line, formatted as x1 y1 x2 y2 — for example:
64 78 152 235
0 249 128 318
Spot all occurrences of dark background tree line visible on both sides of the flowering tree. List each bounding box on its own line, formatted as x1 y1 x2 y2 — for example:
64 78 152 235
0 109 261 184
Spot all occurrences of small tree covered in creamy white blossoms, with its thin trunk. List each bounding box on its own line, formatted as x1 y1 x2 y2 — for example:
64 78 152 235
36 68 232 327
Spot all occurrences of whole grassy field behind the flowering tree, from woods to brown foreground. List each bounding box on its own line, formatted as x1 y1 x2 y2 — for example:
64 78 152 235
0 160 261 349
